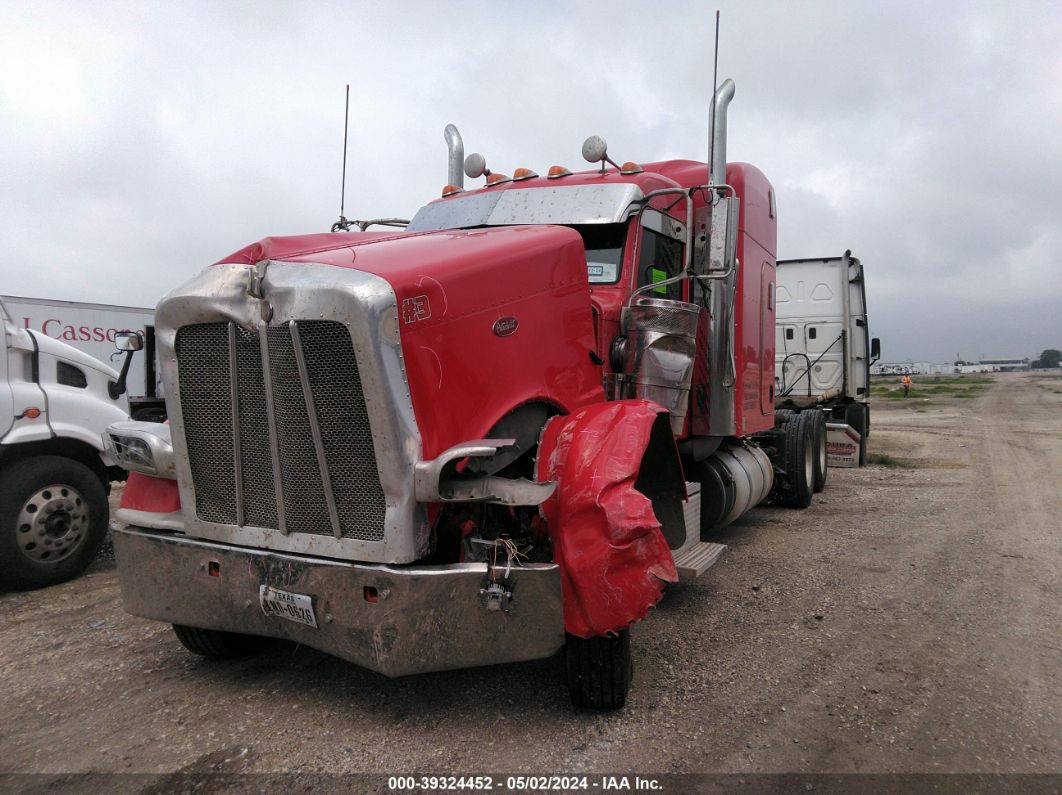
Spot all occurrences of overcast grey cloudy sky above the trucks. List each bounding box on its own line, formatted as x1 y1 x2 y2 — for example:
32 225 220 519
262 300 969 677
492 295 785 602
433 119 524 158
0 0 1062 361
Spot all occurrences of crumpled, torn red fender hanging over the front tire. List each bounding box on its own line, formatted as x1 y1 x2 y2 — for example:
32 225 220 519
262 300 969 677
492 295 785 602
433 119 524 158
536 400 679 638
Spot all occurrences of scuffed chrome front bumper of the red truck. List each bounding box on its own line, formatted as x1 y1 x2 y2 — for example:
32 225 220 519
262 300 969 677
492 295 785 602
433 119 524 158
114 526 564 676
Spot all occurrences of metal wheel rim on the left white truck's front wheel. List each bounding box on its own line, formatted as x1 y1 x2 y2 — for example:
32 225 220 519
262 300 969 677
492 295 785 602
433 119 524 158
15 483 88 564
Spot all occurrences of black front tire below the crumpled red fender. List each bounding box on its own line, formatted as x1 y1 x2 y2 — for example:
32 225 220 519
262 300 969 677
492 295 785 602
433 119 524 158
564 629 633 709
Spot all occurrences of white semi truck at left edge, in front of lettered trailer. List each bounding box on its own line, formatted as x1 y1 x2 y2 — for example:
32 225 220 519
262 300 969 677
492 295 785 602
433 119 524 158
0 301 141 588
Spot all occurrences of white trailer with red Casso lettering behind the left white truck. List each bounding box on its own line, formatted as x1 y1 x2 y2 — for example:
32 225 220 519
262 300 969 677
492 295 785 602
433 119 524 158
0 295 166 421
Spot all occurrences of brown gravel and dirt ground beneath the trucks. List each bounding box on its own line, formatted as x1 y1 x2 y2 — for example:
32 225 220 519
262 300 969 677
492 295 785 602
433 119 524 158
0 375 1062 774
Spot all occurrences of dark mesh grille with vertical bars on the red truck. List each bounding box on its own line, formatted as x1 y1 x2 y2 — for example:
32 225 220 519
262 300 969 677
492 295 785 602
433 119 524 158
176 321 386 541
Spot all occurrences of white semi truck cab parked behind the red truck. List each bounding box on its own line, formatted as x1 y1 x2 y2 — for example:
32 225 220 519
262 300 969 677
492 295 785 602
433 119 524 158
774 250 880 466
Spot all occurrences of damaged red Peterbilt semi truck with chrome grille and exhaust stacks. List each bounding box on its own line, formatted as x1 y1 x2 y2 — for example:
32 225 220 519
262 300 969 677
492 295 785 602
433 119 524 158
101 81 825 708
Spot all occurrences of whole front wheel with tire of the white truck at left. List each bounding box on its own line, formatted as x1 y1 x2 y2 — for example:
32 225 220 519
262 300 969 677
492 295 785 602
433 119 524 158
0 455 110 588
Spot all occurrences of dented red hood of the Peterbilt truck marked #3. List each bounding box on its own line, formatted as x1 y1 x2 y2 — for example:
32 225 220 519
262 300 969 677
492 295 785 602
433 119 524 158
219 226 602 459
